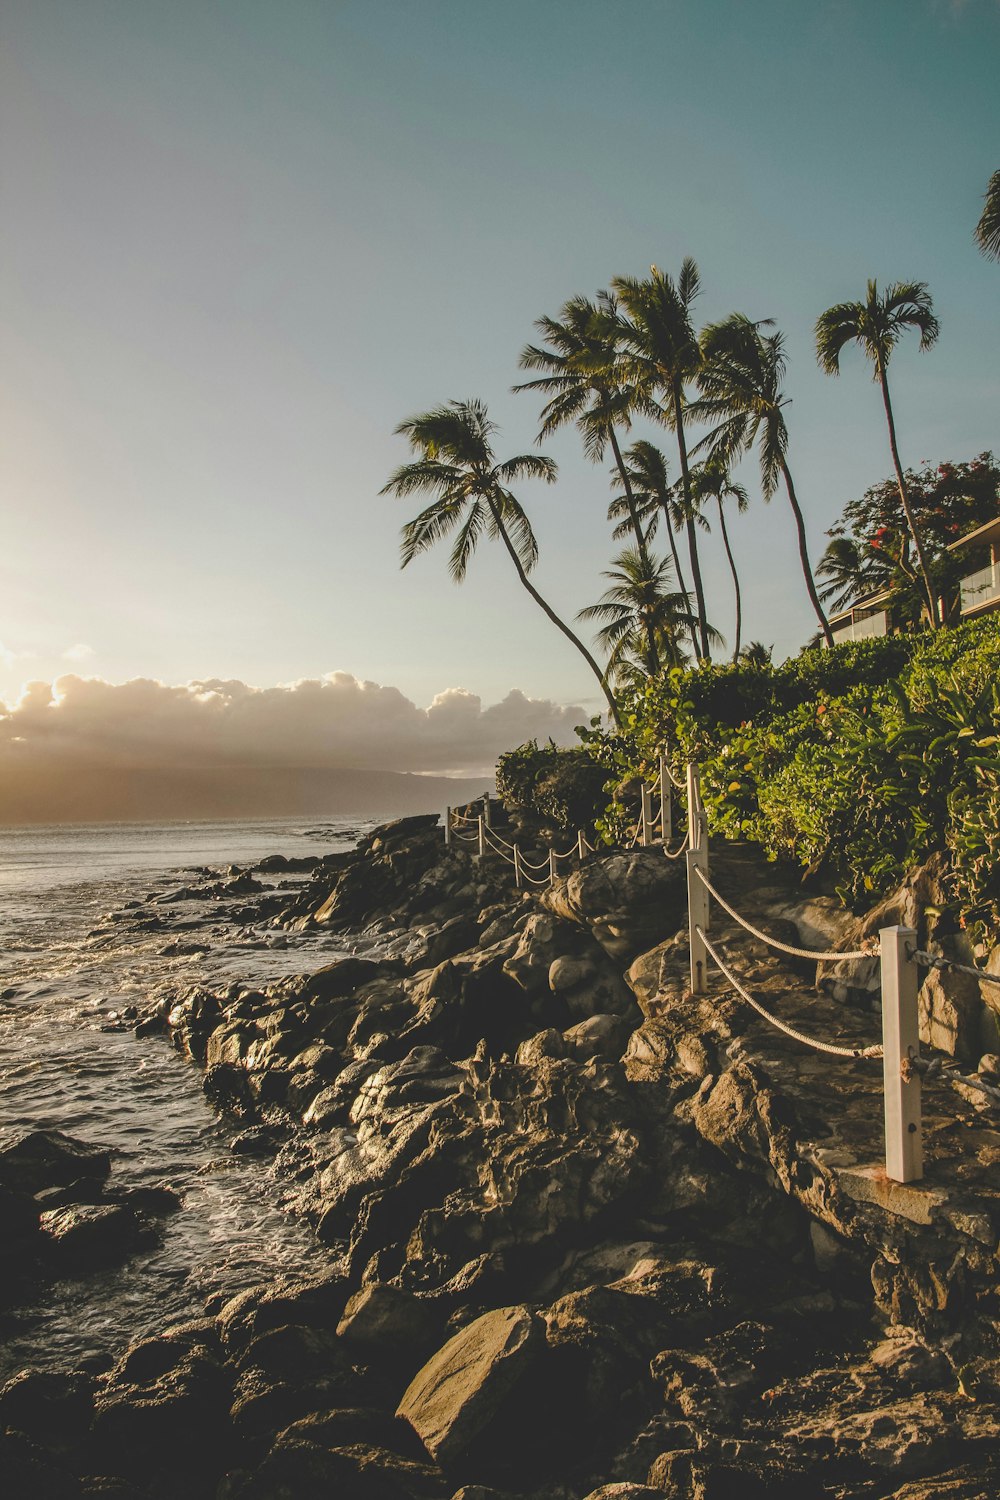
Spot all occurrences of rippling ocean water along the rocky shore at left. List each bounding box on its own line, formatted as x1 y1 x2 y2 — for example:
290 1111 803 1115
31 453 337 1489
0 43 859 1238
0 819 370 1379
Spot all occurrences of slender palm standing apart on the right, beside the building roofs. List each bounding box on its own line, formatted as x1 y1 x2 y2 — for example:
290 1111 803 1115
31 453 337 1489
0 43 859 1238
816 281 940 630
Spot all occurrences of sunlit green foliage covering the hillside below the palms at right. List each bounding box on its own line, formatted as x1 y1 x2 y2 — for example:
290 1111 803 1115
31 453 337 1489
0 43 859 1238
582 615 1000 927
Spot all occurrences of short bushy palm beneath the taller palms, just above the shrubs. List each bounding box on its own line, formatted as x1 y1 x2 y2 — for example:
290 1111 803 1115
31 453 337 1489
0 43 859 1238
577 548 704 684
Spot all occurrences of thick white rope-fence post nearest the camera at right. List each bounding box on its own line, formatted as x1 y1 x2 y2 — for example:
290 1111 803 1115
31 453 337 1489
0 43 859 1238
879 927 924 1182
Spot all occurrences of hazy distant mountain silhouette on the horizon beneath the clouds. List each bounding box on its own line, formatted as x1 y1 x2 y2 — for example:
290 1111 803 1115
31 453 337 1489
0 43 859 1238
0 761 492 825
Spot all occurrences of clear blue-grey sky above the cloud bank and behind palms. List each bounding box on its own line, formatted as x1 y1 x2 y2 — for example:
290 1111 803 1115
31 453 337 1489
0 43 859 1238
0 0 1000 816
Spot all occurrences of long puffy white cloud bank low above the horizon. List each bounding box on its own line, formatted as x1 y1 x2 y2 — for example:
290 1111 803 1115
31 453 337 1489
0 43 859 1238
0 672 588 776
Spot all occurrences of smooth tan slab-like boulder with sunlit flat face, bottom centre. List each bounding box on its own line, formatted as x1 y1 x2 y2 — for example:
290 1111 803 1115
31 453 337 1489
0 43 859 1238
397 1307 544 1467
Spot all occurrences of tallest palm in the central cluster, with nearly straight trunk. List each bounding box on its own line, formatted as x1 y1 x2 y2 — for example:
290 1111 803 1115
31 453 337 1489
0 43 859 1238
612 257 711 660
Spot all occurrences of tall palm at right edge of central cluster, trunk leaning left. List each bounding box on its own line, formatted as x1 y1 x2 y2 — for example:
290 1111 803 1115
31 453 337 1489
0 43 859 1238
694 312 834 645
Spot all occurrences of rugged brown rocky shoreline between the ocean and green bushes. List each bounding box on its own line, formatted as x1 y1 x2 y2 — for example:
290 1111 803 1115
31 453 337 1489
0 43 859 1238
0 816 1000 1500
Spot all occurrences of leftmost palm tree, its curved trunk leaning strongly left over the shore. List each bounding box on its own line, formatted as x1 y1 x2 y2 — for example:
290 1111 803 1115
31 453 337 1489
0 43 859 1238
379 401 619 723
